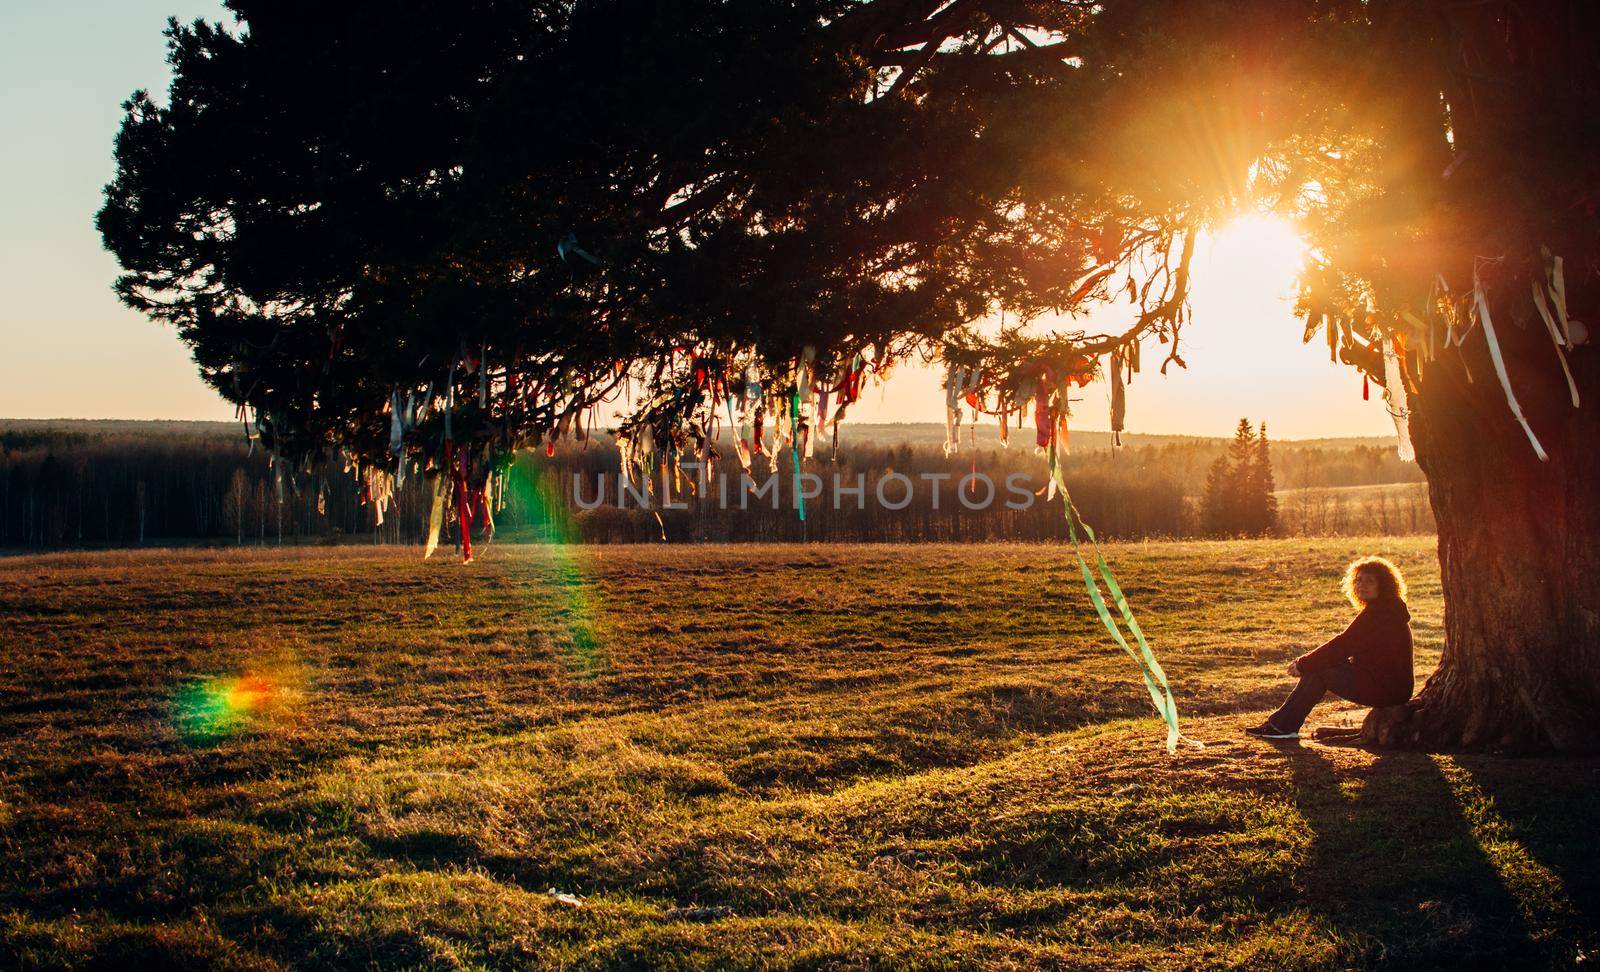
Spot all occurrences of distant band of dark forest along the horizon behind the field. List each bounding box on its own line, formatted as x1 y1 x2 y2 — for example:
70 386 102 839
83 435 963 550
0 420 1434 550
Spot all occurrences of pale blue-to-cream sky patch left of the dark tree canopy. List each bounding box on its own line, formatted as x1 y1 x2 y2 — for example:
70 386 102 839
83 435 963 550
0 0 232 419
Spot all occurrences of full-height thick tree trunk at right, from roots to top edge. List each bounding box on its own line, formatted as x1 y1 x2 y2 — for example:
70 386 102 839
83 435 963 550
1337 0 1600 753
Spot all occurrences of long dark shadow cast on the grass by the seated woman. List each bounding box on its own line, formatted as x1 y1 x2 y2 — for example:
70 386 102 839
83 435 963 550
1283 747 1571 967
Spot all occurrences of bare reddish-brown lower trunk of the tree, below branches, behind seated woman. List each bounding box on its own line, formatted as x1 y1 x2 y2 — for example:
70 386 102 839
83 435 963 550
1366 280 1600 753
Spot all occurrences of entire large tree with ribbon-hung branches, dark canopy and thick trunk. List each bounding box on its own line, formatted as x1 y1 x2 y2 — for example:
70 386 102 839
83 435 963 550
101 0 1600 750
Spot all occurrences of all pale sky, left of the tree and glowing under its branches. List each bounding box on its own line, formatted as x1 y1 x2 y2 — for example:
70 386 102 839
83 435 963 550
0 0 1394 438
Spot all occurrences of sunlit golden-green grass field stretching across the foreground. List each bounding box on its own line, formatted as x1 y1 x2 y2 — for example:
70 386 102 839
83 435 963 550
0 537 1600 969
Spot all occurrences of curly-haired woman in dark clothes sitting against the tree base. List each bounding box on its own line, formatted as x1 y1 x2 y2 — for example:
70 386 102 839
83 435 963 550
1245 556 1411 739
